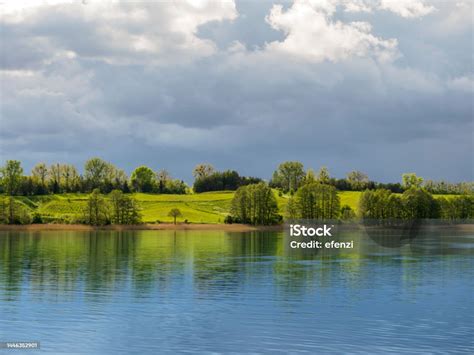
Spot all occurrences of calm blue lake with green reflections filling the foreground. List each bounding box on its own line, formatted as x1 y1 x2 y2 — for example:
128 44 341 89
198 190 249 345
0 228 474 354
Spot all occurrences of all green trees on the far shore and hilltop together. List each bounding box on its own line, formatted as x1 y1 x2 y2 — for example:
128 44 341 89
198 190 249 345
0 158 474 225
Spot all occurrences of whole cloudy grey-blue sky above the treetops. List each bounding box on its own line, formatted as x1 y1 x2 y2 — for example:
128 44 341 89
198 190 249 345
0 0 474 182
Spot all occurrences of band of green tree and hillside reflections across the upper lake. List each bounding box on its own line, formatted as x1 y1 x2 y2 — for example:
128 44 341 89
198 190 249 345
0 226 472 301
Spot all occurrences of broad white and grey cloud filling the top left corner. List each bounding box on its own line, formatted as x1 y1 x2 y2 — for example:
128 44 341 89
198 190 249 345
1 0 237 64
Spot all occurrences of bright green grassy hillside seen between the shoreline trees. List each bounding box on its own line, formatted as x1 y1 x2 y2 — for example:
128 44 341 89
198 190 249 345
10 191 456 223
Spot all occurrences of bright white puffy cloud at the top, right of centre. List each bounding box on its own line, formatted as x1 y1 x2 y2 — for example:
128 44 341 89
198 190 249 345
266 0 397 62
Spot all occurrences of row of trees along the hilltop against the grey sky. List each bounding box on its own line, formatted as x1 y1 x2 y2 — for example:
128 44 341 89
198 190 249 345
0 158 474 196
